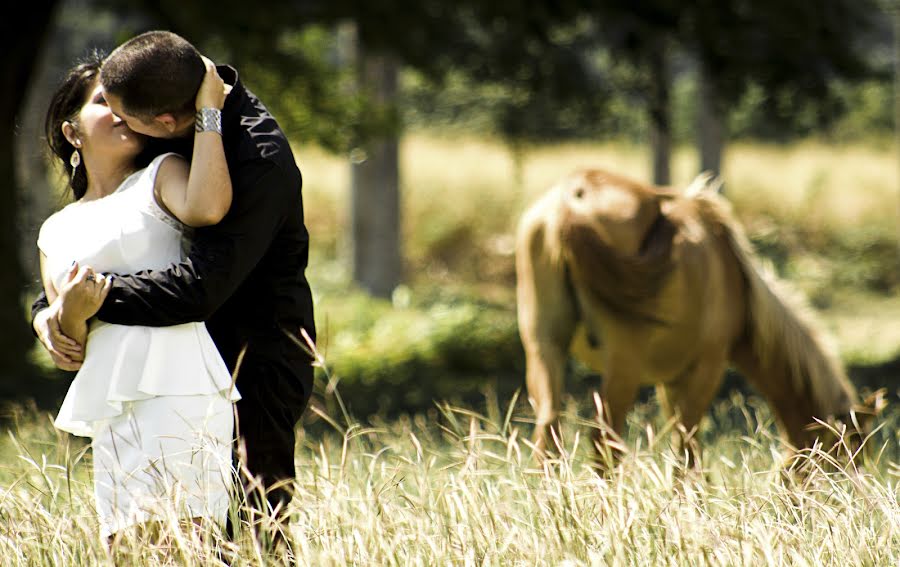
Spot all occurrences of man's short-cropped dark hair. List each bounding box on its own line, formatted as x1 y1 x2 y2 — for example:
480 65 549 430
100 31 206 118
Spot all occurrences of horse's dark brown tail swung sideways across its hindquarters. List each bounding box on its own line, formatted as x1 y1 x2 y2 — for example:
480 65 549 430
559 200 675 323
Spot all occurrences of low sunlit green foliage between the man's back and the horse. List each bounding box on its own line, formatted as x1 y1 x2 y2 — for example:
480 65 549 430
316 288 524 416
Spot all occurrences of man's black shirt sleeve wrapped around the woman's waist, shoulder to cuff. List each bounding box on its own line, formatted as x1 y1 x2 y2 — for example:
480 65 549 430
97 162 288 327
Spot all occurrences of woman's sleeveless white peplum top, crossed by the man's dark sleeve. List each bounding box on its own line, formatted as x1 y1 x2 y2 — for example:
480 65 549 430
38 154 240 437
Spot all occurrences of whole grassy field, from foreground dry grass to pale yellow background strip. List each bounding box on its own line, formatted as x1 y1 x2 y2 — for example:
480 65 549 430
12 134 900 566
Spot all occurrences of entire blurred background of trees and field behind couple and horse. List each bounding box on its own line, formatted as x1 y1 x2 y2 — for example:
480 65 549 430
0 0 900 417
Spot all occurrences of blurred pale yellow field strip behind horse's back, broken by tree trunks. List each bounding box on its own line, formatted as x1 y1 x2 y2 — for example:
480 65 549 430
296 133 900 258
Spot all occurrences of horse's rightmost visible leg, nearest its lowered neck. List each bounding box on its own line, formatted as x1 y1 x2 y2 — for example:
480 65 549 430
656 353 728 467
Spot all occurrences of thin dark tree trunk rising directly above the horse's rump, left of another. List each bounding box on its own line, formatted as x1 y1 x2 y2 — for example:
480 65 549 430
648 45 672 185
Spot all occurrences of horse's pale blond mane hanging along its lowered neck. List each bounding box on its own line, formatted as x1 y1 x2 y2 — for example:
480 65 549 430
693 192 857 424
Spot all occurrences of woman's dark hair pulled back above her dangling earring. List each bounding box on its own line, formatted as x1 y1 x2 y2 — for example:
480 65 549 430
44 51 103 201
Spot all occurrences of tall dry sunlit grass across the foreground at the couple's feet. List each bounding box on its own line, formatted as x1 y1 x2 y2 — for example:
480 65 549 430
0 390 900 566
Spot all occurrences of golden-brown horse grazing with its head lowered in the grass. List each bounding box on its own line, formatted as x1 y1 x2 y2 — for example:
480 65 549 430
516 169 884 466
